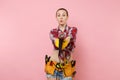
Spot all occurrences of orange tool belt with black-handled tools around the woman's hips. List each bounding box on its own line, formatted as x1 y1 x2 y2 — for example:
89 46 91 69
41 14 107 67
45 55 76 77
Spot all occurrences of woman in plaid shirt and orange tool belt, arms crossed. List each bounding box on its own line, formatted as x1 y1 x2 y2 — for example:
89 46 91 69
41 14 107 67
45 8 77 80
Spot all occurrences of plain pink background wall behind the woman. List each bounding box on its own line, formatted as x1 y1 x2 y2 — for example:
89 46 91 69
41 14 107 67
0 0 120 80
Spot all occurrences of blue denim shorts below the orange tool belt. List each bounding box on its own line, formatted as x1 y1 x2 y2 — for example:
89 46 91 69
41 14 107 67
46 70 72 80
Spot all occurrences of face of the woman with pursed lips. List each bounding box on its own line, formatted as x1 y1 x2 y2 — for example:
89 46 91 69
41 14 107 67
56 10 68 25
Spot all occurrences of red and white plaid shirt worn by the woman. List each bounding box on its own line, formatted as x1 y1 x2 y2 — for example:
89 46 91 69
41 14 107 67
50 25 77 60
